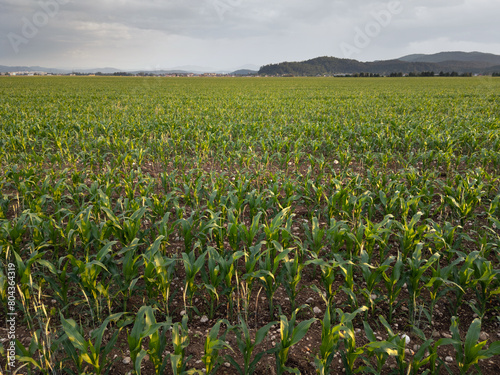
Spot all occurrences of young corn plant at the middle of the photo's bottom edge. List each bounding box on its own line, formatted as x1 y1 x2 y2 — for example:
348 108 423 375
225 316 277 375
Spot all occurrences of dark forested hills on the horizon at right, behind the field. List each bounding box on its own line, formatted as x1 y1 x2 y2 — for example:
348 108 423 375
259 52 500 76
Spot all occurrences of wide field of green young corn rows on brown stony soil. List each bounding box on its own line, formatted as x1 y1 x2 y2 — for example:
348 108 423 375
0 77 500 375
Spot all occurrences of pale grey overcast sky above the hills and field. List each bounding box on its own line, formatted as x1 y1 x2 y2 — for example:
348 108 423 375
0 0 500 70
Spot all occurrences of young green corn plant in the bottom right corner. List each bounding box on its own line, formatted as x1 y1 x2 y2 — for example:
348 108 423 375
450 316 500 375
